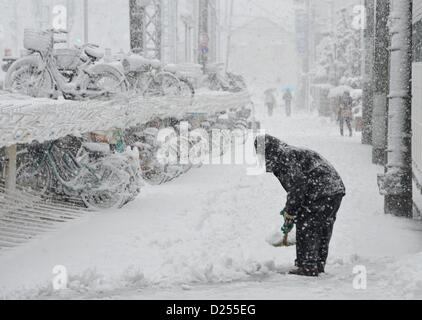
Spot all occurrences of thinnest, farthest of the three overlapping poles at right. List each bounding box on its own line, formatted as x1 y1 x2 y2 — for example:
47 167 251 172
362 0 375 145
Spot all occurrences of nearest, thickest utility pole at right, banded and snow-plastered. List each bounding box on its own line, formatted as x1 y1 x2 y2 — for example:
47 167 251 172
383 0 413 218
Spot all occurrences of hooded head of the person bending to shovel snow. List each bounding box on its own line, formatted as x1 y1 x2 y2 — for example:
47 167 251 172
255 134 289 173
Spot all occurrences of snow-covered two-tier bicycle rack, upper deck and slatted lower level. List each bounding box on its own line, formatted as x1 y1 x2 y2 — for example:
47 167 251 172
0 91 251 254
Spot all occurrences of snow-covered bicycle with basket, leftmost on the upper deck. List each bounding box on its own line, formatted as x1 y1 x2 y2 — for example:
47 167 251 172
5 29 128 100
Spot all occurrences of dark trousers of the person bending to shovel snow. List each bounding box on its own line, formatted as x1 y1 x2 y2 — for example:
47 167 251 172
296 195 343 269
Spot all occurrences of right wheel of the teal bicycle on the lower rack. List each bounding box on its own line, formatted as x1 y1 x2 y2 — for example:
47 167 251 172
81 164 127 211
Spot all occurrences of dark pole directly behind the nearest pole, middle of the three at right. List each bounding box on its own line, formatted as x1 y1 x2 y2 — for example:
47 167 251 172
372 0 390 165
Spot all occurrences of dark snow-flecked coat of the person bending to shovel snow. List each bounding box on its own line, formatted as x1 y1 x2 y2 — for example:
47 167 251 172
255 135 346 216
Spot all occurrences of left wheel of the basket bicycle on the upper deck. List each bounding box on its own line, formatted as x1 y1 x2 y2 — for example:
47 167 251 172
5 56 54 98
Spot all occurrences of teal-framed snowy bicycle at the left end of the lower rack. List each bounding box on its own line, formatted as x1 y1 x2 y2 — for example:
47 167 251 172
16 142 140 210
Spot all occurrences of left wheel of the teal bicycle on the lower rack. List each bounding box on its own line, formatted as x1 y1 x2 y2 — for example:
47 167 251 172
16 162 52 195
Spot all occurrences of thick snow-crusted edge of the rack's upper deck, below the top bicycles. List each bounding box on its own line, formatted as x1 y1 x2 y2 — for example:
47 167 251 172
0 91 251 147
